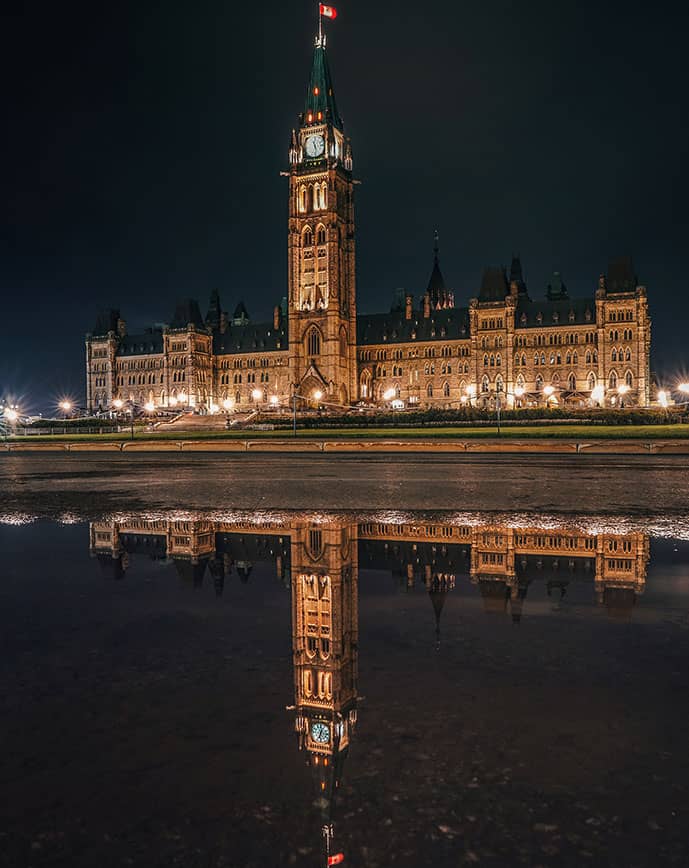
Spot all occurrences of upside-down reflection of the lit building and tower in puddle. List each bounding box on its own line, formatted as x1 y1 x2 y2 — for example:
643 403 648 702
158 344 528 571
90 514 649 864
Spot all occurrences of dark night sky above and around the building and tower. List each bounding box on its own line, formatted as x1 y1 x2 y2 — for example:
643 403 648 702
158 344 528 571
0 0 689 409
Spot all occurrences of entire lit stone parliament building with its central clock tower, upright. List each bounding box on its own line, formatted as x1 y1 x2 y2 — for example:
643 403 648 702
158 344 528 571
86 28 651 413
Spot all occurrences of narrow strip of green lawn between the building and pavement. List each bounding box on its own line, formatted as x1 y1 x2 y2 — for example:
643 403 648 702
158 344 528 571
4 425 689 443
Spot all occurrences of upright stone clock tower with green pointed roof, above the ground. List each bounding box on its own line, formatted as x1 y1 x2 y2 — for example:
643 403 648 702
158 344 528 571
288 32 357 405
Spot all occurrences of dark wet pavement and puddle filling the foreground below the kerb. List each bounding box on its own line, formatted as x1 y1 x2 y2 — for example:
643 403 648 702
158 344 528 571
0 456 689 868
